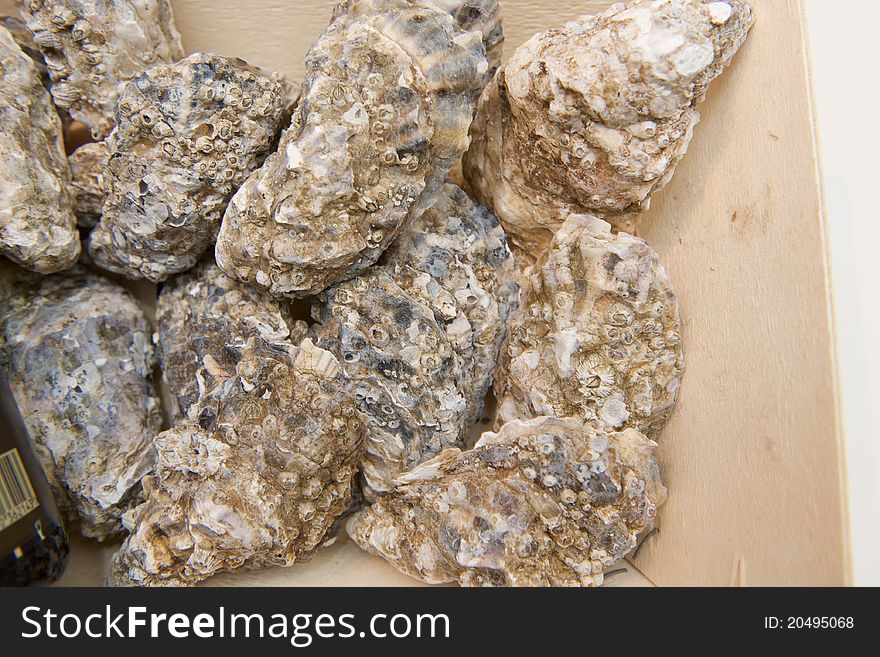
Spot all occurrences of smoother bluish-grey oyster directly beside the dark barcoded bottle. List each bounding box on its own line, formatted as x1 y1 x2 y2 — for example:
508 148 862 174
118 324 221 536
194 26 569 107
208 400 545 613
0 267 162 539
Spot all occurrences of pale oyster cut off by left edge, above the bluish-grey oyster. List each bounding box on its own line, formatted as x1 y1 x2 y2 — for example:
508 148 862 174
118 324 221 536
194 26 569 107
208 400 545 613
0 26 80 274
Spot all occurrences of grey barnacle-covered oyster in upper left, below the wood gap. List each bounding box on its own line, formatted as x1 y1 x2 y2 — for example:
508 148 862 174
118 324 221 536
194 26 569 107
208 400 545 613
89 53 288 282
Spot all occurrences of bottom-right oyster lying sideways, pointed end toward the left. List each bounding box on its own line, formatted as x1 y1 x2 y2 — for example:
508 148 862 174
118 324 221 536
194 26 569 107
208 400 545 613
347 417 666 586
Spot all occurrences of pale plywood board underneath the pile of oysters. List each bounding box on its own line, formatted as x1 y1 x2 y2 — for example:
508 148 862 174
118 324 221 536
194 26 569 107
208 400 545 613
0 0 849 585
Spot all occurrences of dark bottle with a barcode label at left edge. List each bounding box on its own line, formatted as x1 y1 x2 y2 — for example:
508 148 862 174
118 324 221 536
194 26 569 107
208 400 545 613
0 370 70 586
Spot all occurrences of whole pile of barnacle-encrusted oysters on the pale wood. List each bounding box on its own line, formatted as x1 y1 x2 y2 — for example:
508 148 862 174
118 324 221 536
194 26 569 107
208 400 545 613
0 0 753 586
